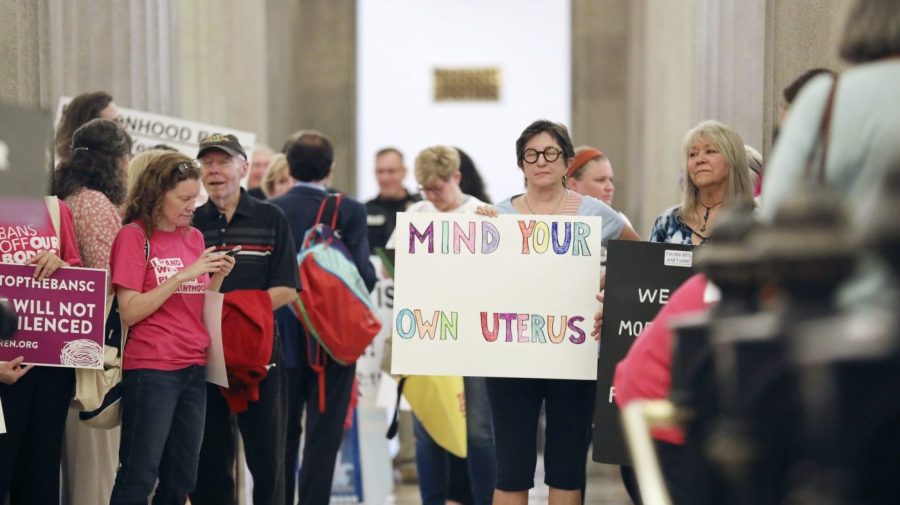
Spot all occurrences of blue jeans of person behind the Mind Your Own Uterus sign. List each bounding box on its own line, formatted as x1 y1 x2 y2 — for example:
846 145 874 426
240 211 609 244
413 377 497 505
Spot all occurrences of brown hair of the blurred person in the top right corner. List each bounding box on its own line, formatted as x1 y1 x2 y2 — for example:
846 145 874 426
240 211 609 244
838 0 900 63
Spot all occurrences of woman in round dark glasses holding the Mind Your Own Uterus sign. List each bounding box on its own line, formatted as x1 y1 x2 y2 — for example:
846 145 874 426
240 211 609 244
478 120 640 505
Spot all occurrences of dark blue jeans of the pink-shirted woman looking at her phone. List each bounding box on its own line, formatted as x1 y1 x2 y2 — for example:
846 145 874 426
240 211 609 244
110 365 206 505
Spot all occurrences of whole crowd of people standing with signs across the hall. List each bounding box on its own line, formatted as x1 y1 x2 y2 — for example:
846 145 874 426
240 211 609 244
0 1 900 505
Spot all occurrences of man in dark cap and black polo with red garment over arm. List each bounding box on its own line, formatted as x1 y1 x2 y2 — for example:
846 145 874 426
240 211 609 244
190 133 300 505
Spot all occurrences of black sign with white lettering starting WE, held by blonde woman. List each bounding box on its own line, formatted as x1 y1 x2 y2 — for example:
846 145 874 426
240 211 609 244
593 240 694 465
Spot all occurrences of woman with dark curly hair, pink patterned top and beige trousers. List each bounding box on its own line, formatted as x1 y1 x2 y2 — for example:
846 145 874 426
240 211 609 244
53 118 132 504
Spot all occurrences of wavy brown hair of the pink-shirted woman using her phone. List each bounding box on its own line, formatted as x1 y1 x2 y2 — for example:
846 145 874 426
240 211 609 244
122 152 200 237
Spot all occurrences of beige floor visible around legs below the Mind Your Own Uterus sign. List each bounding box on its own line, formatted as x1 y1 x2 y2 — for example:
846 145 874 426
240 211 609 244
385 459 631 505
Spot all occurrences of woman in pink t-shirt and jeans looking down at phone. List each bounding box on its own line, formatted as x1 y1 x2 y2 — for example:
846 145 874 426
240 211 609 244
110 152 234 505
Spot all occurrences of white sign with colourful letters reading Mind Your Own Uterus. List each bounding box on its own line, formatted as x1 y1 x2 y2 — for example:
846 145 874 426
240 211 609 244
391 213 601 380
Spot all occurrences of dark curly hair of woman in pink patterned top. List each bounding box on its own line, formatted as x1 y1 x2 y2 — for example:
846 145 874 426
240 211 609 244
53 119 131 205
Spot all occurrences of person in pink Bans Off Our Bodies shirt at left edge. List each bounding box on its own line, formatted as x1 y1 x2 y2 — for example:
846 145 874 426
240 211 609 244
0 193 81 504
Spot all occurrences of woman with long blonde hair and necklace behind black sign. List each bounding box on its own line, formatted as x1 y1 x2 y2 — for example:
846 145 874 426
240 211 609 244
650 121 753 245
